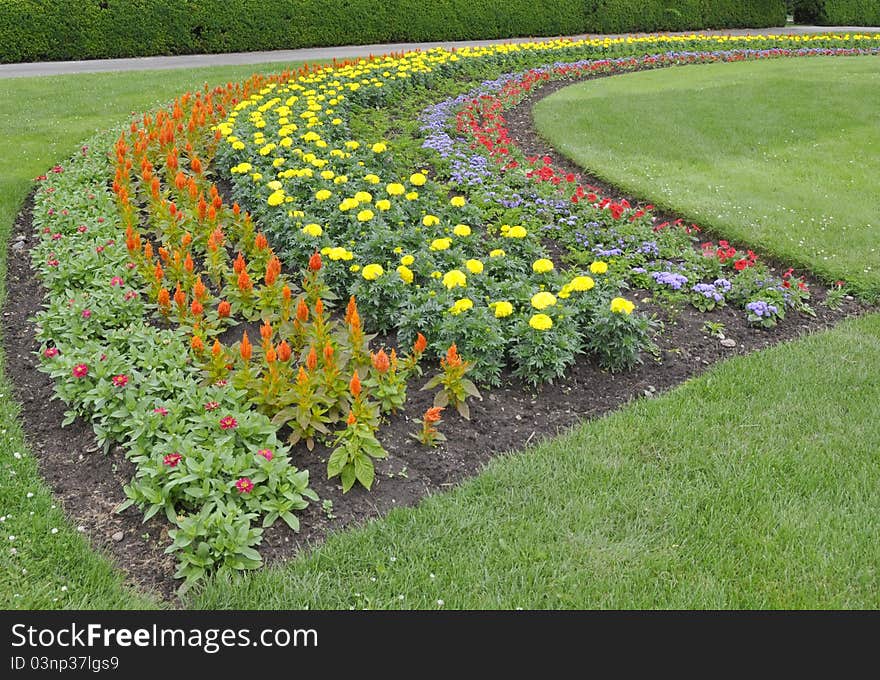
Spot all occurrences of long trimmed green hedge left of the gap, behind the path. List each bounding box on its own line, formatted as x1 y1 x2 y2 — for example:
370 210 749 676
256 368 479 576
0 0 785 63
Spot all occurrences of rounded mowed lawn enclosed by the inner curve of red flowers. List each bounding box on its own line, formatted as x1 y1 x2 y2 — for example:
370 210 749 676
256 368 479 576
535 56 880 299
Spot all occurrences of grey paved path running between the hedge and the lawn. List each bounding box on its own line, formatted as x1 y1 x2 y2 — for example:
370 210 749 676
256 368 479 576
0 26 880 78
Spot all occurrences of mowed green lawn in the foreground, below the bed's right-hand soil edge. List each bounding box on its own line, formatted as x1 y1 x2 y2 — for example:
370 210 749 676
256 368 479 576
189 315 880 609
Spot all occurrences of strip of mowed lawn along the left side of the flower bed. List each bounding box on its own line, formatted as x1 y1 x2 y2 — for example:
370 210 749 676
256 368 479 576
0 64 312 609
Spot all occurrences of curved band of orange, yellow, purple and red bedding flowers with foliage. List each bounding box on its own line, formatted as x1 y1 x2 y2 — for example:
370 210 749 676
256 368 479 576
27 31 876 582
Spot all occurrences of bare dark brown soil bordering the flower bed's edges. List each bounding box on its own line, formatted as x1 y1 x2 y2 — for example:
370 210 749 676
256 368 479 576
2 83 869 606
